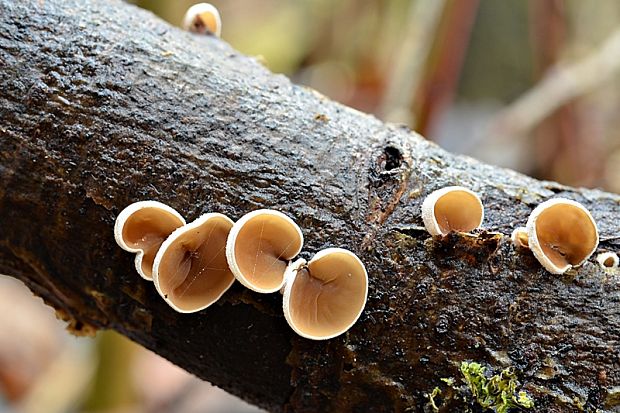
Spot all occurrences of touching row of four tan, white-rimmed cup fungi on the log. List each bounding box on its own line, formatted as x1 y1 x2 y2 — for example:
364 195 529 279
114 201 368 340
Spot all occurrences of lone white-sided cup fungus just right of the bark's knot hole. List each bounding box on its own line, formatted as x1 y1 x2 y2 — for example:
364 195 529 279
422 186 484 236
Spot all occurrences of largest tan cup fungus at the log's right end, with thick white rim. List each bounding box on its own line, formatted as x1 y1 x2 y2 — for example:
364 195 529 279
526 198 598 274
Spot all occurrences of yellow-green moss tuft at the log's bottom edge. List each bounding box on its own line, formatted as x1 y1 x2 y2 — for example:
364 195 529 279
460 361 534 413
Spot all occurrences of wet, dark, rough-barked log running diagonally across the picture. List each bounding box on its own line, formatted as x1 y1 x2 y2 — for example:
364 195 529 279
0 0 620 412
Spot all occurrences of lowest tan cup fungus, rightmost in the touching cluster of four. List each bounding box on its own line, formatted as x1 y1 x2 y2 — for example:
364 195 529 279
282 248 368 340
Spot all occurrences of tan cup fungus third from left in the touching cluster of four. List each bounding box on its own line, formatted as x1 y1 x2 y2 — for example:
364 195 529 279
226 209 304 293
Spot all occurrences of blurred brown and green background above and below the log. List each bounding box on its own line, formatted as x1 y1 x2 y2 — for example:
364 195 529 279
0 0 620 413
